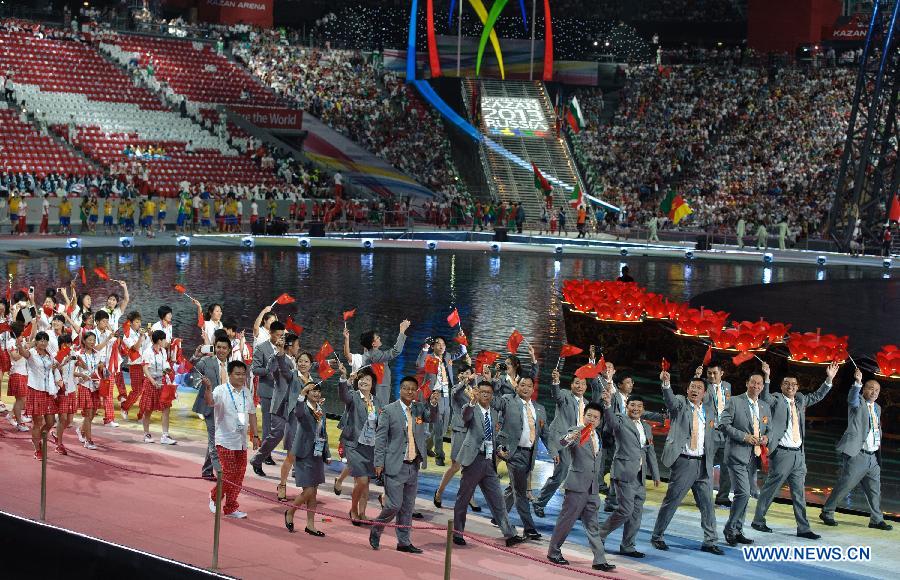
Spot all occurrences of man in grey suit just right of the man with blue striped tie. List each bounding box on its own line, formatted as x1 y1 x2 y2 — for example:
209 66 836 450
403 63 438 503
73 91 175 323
497 376 548 540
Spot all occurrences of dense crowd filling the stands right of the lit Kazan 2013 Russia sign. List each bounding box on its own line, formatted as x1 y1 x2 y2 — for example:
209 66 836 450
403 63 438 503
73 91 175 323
574 63 855 238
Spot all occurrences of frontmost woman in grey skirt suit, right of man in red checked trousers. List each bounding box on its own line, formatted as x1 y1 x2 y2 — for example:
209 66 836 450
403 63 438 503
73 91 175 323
284 383 331 537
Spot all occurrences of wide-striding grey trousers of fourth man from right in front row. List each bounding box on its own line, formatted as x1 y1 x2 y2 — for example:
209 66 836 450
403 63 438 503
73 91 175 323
651 457 718 546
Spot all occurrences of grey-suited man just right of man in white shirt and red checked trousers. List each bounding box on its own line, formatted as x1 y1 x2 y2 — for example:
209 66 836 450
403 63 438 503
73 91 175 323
250 333 305 477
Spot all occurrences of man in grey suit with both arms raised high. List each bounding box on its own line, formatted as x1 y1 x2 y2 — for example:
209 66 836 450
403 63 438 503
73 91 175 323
751 363 838 540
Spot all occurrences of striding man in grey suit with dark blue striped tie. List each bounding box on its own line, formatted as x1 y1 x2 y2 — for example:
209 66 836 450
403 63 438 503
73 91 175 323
453 381 525 547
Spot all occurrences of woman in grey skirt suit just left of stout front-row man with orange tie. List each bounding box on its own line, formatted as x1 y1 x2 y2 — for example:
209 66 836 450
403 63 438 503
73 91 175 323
338 365 386 526
